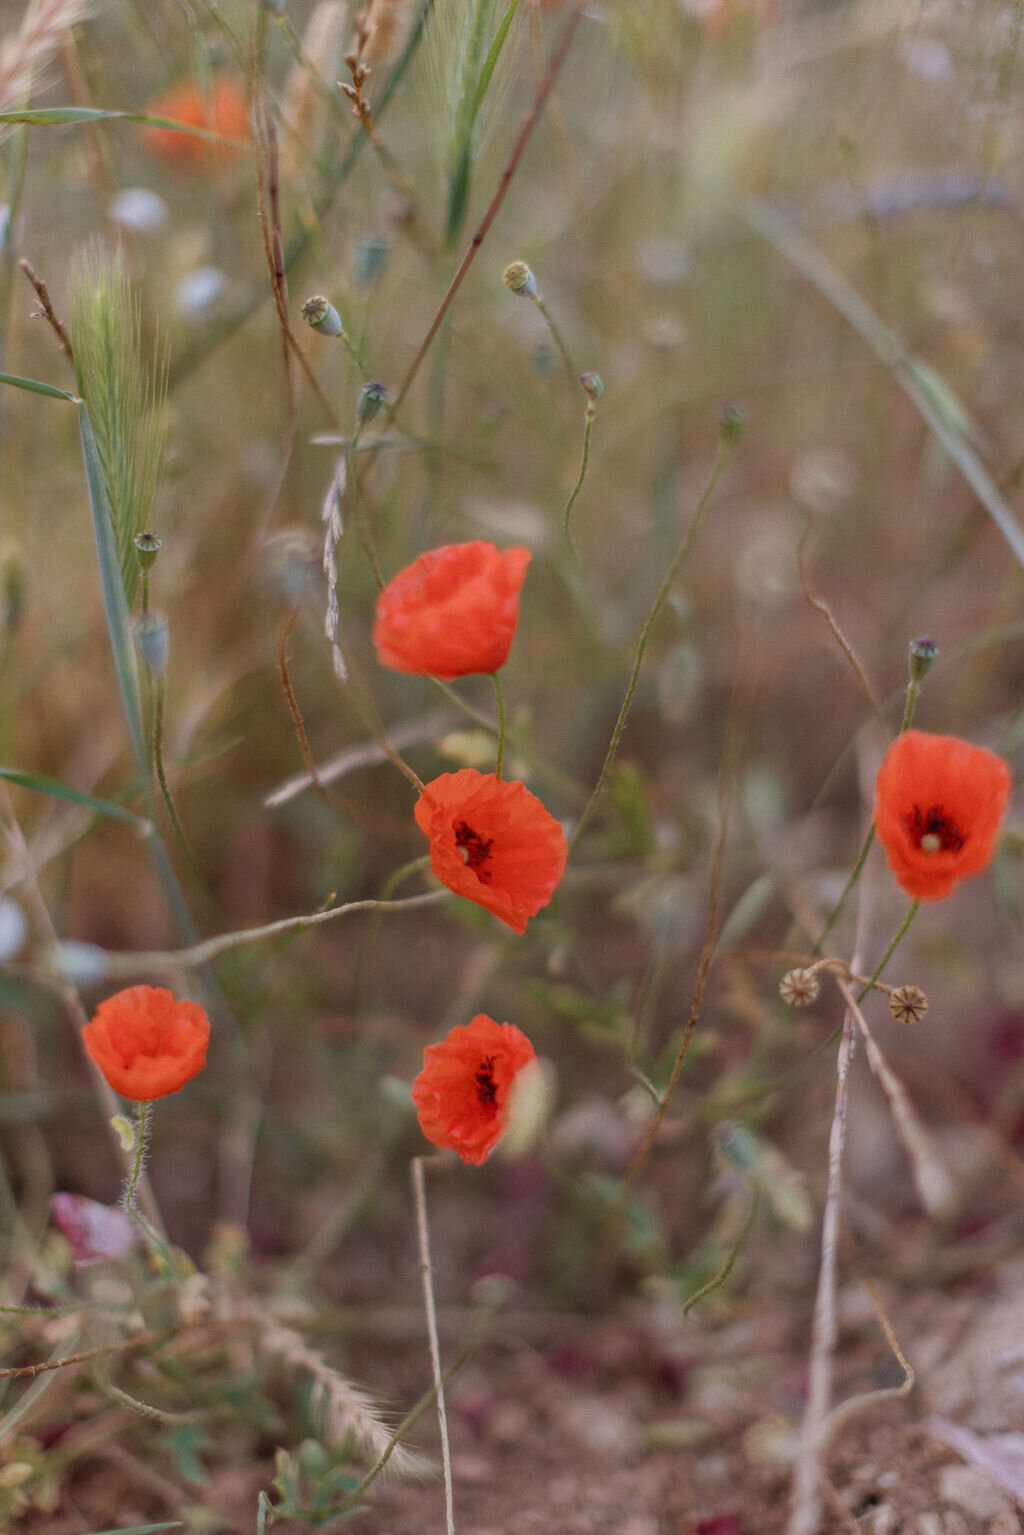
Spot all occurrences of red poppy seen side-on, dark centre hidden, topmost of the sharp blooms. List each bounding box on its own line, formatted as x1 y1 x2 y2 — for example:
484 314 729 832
373 539 531 682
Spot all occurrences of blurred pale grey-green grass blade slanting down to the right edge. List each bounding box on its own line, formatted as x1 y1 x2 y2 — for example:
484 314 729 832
737 198 1024 565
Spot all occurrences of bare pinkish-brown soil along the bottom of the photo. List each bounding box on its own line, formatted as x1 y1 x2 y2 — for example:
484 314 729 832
17 1260 1024 1535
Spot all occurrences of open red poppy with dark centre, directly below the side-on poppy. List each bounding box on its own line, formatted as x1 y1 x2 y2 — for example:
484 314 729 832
416 768 567 933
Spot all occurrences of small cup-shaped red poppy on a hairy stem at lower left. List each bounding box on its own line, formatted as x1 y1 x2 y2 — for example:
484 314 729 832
81 985 210 1104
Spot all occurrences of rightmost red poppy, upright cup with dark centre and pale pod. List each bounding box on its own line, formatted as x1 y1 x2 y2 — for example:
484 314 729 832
875 731 1010 901
